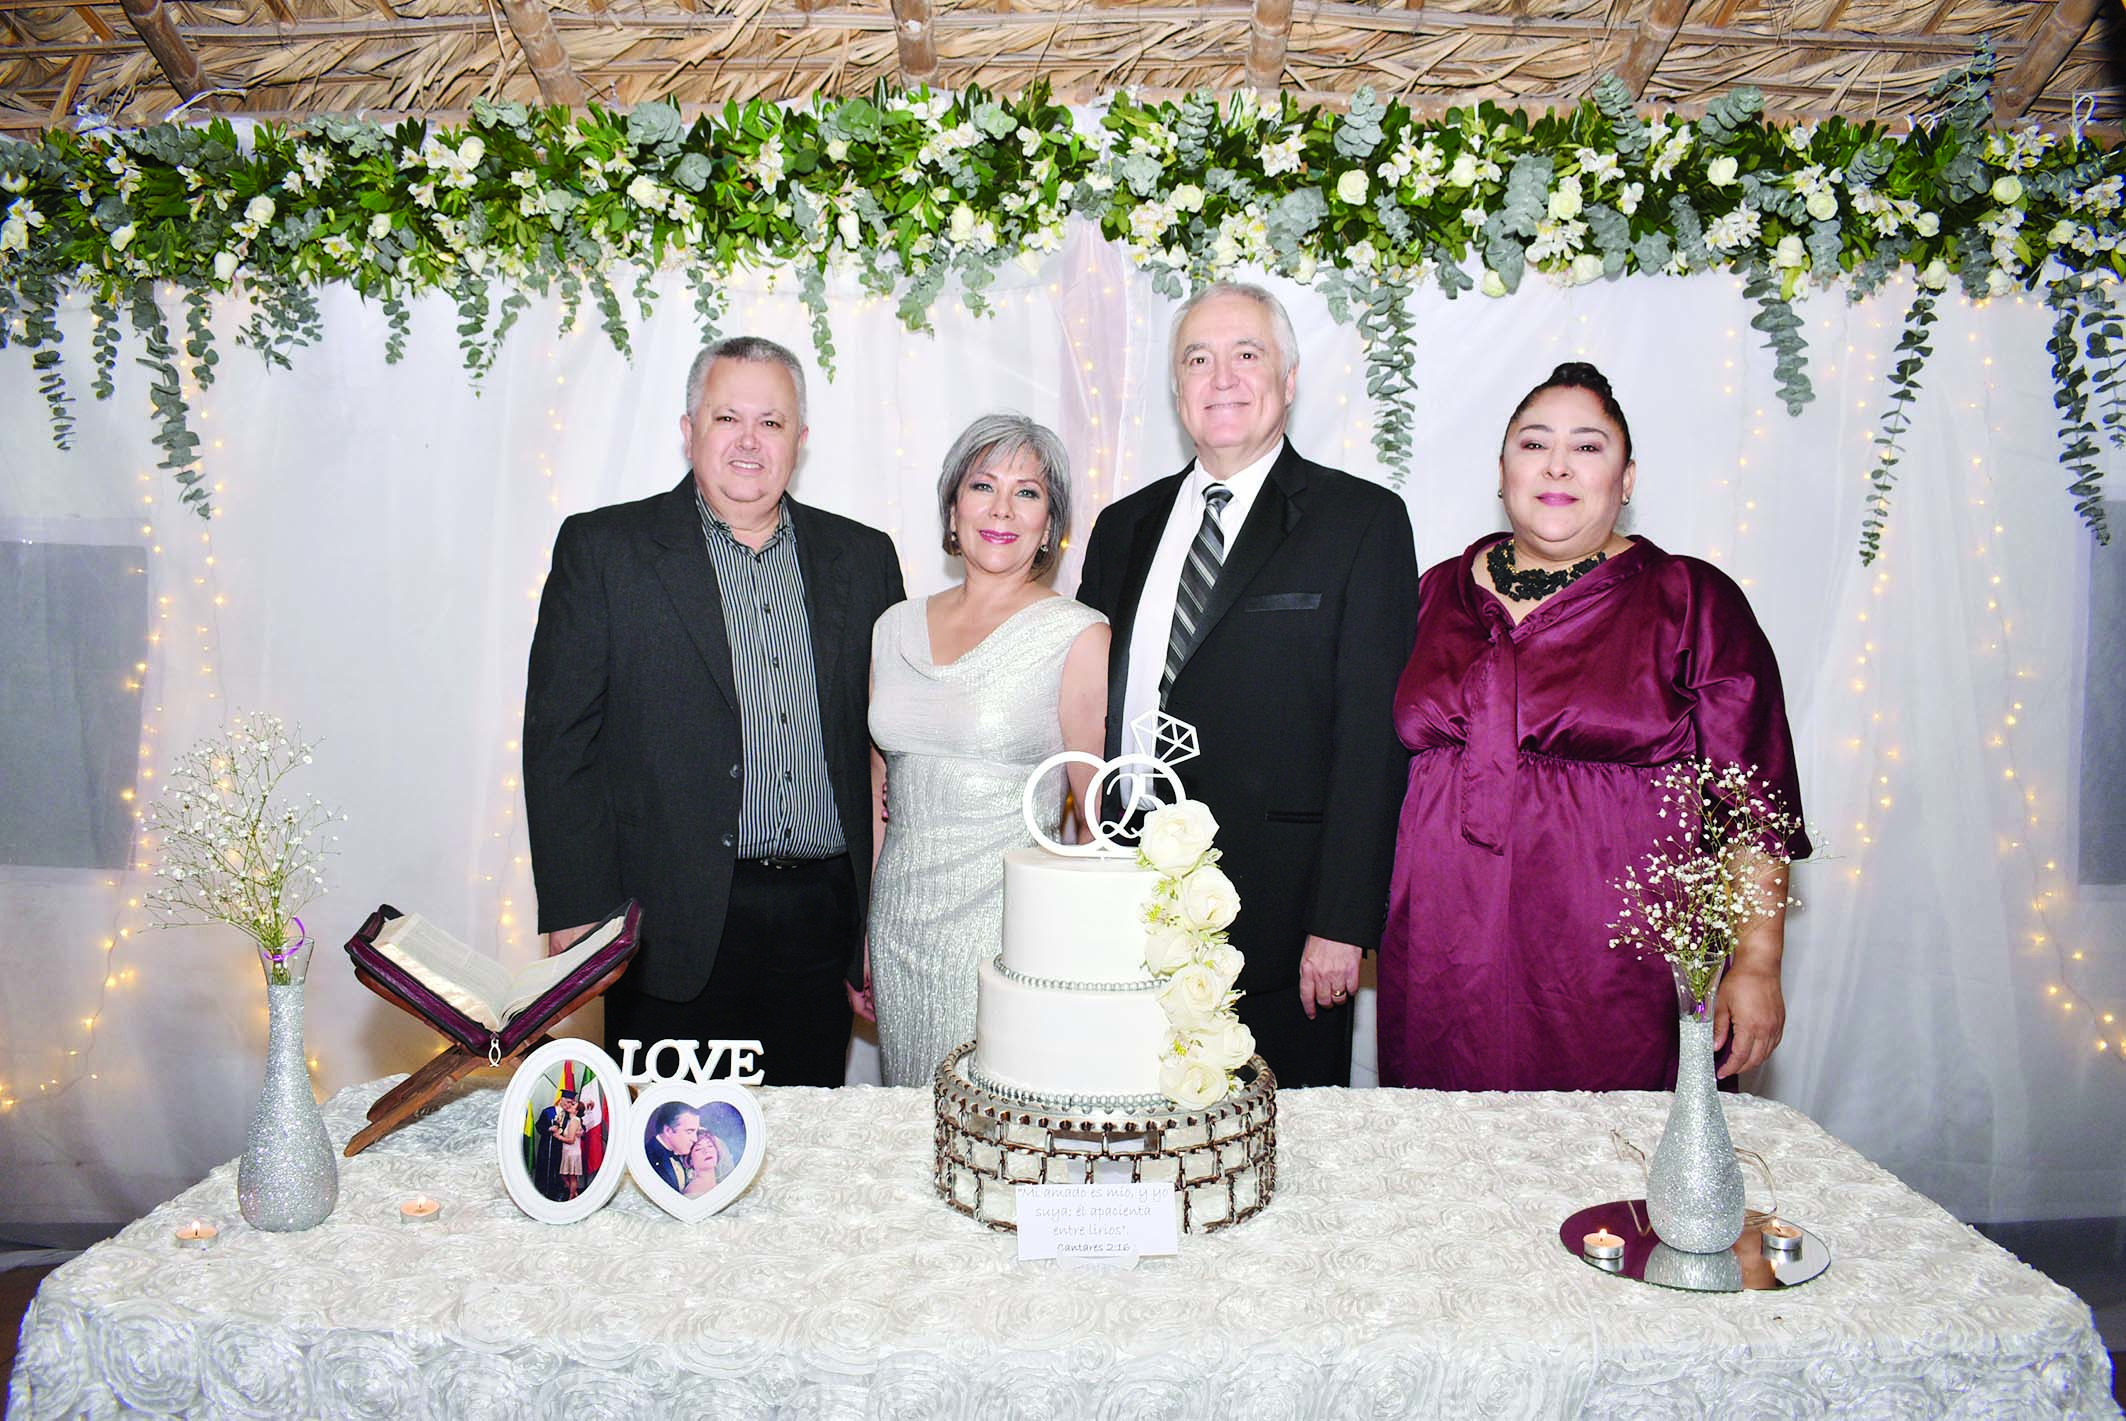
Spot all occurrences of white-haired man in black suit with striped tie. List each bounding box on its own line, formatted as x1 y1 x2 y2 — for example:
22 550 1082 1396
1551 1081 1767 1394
1078 283 1418 1085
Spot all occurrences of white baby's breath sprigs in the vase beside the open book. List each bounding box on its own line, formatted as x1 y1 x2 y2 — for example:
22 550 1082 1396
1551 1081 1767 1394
147 713 340 987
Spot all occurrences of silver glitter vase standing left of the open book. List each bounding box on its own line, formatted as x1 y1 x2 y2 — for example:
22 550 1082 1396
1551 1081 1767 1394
236 981 340 1234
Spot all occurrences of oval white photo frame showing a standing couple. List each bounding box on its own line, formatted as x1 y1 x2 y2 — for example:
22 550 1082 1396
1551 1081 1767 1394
495 1036 636 1223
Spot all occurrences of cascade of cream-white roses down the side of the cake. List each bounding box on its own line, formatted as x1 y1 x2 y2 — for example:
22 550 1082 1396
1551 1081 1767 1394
1137 800 1254 1106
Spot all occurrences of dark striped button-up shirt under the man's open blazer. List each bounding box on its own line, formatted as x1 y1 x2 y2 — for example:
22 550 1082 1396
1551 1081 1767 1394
693 485 848 859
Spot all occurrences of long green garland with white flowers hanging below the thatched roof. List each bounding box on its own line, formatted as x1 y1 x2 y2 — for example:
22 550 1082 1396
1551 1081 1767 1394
0 49 2126 557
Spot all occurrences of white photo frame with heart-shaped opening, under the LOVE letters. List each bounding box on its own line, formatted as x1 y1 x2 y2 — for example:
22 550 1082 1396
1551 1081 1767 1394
627 1081 767 1223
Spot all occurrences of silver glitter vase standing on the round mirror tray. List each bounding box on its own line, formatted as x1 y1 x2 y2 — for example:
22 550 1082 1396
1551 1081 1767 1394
1646 972 1743 1253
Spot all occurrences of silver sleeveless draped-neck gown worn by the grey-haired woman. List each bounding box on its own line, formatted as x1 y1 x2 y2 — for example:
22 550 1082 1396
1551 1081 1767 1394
870 598 1103 1085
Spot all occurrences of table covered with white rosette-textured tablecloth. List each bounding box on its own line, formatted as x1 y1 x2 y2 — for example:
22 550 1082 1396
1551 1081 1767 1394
9 1081 2120 1421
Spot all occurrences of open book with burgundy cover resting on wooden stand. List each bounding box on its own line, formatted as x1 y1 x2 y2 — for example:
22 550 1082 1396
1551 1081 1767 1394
347 900 642 1061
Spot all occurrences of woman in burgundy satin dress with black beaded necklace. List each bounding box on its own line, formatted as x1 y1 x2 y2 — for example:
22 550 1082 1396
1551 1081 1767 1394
1380 362 1809 1091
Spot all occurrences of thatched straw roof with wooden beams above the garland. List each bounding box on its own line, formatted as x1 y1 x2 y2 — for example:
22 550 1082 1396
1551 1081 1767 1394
0 0 2126 130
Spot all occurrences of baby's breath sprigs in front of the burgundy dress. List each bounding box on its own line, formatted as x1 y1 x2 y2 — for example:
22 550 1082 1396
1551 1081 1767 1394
1609 759 1801 1017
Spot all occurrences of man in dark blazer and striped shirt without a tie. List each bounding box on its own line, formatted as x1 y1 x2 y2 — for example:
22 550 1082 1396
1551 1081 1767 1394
523 336 906 1085
